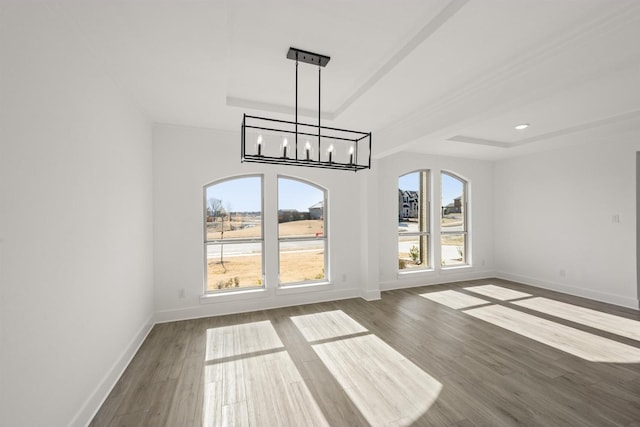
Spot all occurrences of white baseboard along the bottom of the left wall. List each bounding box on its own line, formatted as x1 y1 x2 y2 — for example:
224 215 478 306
69 316 153 426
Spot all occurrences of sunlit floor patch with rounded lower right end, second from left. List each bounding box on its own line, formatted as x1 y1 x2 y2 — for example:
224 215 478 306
292 310 442 427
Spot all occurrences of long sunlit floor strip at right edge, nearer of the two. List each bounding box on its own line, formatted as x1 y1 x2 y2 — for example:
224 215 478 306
464 305 640 363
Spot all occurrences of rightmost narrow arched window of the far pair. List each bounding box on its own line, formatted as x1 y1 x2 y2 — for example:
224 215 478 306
440 172 469 266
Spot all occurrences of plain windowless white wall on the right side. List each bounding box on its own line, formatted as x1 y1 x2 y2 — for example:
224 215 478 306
495 127 640 308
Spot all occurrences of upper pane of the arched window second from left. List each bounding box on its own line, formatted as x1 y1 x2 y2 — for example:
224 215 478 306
278 178 325 238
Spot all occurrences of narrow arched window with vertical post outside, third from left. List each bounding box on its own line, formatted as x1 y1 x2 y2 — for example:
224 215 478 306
398 170 430 273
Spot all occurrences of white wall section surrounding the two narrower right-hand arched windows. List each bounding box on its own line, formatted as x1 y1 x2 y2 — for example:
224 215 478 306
372 153 493 290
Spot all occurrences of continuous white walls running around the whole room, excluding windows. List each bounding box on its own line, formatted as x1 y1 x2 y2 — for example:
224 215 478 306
0 2 640 426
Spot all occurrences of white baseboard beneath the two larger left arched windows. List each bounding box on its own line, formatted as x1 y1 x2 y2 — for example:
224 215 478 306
155 289 360 323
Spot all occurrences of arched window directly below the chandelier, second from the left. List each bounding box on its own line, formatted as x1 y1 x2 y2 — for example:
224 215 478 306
278 177 328 285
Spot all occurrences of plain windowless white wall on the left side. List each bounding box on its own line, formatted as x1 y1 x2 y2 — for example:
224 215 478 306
0 2 153 426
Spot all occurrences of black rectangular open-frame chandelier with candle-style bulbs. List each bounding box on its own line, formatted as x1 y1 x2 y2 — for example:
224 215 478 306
241 47 371 172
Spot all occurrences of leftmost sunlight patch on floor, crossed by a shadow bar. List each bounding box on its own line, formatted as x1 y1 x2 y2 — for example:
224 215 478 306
203 321 328 427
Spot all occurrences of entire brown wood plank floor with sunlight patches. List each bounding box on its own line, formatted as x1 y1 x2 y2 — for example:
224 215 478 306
91 279 640 427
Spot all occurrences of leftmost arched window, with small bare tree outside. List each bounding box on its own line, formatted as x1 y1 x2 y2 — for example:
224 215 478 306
204 176 264 292
